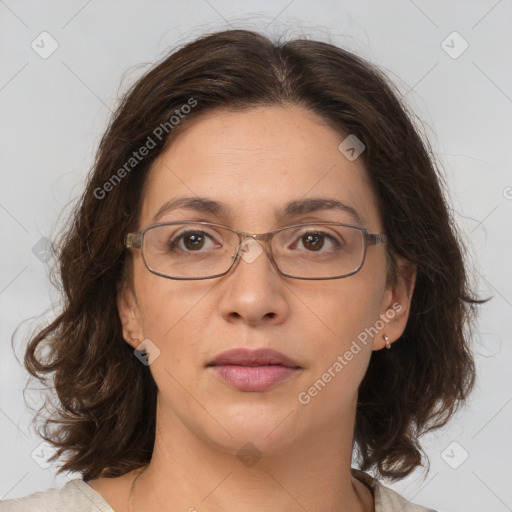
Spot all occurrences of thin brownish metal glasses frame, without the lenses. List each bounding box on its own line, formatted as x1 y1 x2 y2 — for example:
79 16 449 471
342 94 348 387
124 220 388 281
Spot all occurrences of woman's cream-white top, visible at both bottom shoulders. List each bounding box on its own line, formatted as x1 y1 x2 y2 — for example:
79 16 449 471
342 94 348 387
0 469 435 512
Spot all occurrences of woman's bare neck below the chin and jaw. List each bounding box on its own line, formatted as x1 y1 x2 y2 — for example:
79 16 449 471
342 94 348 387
129 396 373 512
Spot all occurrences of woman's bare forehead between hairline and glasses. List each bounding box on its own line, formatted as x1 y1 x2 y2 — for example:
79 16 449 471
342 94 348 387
140 105 380 230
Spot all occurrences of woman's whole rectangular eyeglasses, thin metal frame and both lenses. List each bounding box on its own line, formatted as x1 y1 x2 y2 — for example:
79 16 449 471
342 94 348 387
125 221 387 280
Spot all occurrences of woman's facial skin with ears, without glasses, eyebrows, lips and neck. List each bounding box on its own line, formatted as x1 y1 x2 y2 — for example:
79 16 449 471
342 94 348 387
119 106 410 453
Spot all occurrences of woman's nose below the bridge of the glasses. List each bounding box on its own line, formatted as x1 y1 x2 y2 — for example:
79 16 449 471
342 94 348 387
219 239 289 325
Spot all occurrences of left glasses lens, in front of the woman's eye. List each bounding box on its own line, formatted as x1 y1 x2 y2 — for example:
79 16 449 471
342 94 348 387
143 223 238 279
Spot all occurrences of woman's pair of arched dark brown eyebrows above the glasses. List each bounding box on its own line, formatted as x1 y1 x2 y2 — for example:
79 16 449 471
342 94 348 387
152 197 364 225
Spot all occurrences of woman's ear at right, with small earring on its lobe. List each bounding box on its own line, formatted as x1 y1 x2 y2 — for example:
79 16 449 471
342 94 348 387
373 261 416 350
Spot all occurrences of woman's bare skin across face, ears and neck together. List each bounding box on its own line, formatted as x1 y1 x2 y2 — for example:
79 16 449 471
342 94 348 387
90 105 414 512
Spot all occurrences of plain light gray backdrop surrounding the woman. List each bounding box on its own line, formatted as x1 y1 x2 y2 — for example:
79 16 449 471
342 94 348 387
0 0 512 512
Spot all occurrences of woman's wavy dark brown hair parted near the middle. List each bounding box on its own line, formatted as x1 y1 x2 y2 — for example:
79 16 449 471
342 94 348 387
21 30 482 480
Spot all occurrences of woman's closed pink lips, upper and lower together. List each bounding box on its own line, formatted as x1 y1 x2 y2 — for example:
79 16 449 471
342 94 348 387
207 349 301 391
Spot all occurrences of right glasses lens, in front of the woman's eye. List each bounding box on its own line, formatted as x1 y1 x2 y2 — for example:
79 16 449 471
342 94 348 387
272 224 365 279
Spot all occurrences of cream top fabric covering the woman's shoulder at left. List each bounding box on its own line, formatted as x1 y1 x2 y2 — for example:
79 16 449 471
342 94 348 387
0 479 114 512
